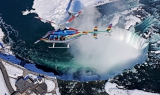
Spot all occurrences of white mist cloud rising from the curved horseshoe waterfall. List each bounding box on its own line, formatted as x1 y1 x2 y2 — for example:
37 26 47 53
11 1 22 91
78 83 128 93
69 8 147 79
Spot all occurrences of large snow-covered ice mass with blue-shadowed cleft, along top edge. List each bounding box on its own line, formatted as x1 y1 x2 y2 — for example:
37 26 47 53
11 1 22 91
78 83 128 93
22 0 119 23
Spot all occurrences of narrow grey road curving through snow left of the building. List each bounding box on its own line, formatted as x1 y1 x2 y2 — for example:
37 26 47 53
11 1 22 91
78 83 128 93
0 62 14 94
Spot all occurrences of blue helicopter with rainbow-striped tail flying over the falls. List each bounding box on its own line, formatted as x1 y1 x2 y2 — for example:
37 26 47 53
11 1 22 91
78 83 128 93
34 11 112 48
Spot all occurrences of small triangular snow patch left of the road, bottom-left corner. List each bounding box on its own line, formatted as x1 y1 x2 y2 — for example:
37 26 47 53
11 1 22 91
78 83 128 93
0 70 10 95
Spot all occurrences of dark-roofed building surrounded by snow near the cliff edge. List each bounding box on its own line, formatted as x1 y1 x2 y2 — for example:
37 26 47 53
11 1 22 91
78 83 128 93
13 76 47 95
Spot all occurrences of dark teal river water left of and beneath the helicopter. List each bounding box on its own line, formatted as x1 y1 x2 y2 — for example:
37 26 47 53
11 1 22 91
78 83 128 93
0 0 72 74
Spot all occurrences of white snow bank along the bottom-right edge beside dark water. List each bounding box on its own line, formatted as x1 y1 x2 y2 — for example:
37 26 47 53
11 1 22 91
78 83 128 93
105 82 159 95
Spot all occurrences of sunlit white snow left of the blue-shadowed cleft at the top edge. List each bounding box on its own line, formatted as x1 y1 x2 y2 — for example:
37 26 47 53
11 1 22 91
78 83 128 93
32 0 69 23
